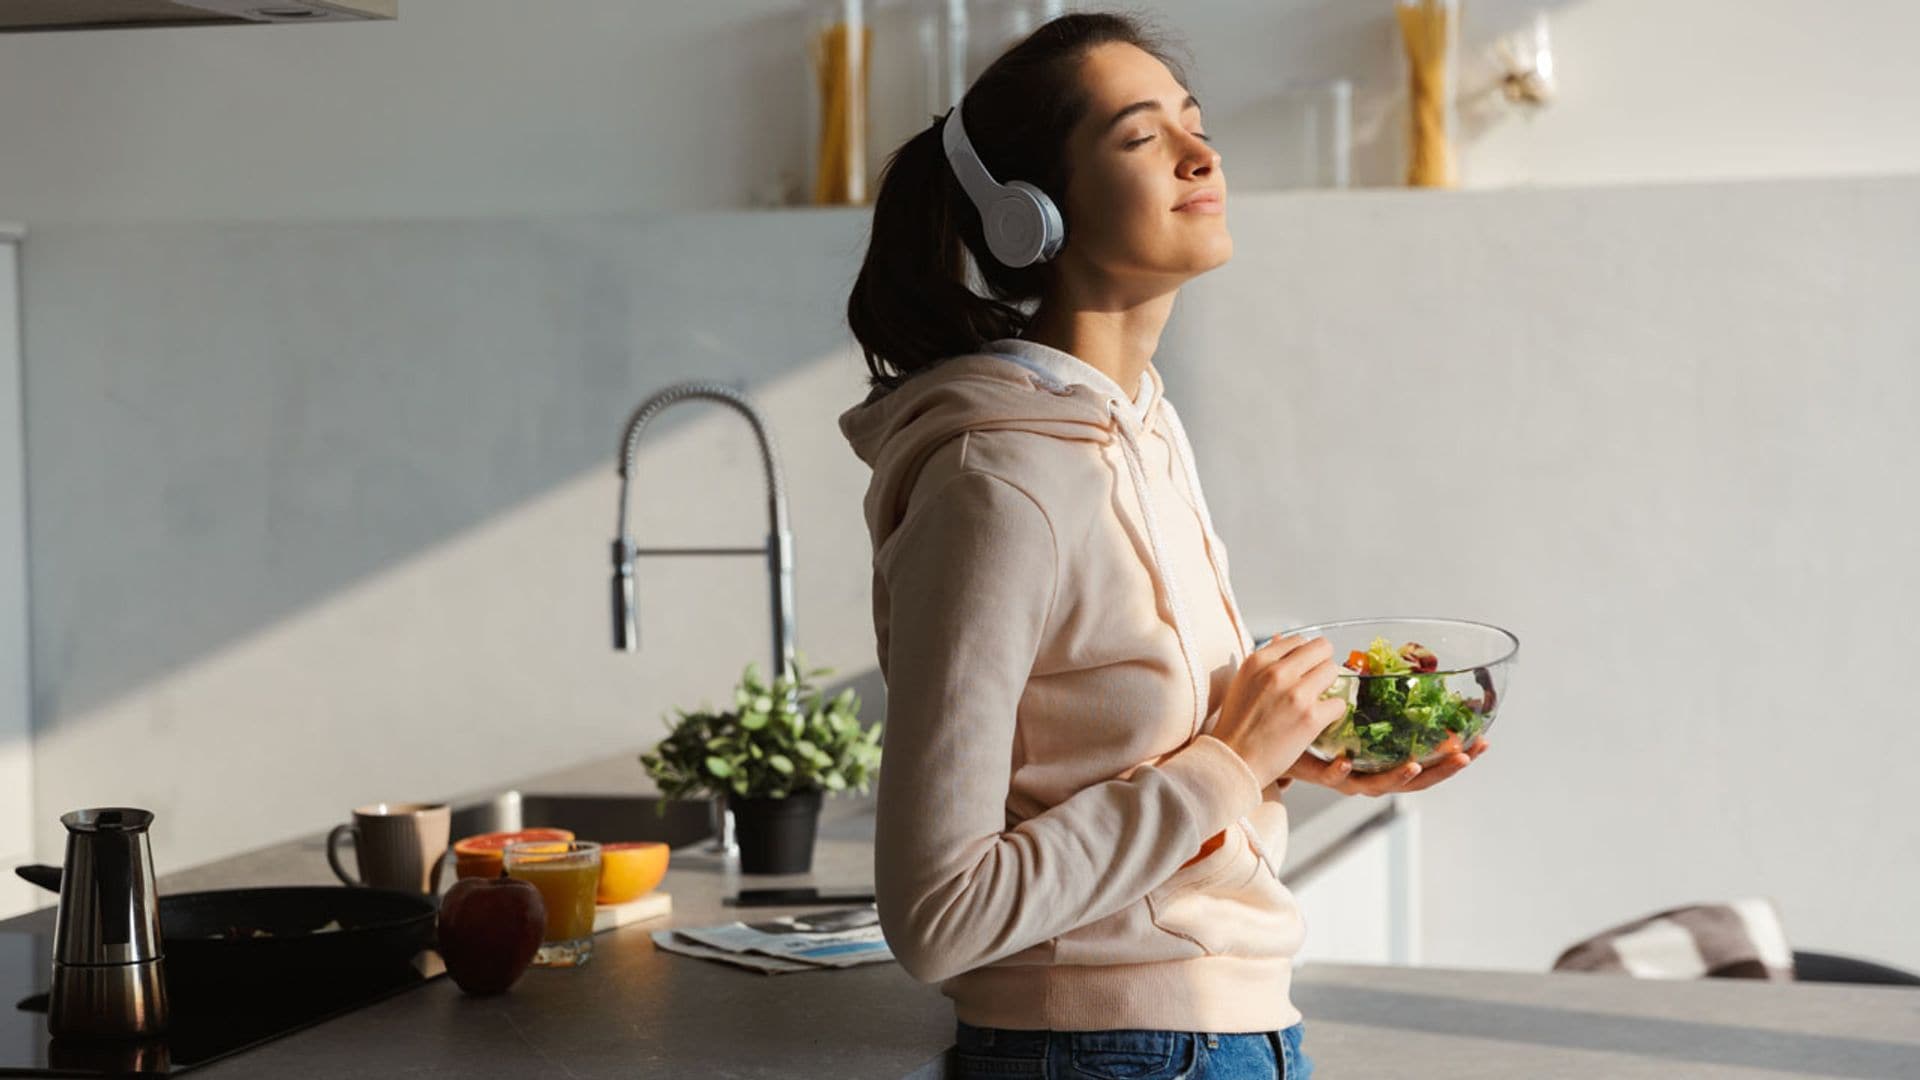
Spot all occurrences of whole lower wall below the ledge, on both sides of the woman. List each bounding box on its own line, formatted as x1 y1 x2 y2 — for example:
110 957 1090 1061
25 171 1920 970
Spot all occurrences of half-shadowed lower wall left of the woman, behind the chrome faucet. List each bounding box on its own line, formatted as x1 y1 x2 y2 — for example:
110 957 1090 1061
25 211 883 871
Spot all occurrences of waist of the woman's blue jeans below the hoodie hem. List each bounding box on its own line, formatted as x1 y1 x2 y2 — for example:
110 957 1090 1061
954 1020 1313 1080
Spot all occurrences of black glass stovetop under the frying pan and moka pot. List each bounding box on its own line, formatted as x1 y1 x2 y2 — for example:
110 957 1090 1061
0 932 442 1076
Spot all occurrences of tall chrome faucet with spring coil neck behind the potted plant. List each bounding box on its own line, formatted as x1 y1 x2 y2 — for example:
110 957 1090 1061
612 382 793 853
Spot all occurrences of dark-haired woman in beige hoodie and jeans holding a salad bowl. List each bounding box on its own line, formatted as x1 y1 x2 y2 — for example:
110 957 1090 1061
841 13 1486 1080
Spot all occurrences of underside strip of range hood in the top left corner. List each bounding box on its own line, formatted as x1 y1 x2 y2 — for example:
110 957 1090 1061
0 0 399 33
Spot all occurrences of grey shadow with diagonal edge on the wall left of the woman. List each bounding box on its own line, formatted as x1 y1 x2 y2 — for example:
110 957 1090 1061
23 215 864 730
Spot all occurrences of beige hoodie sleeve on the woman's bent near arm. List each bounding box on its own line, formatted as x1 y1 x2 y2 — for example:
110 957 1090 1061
874 463 1263 982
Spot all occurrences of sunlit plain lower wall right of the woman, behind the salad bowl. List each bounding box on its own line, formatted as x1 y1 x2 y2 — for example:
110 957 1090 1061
1162 179 1920 970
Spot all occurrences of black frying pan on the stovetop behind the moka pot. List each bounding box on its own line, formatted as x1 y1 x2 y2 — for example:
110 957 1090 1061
13 867 438 984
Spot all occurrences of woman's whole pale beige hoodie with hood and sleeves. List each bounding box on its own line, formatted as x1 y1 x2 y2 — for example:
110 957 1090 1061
839 338 1306 1032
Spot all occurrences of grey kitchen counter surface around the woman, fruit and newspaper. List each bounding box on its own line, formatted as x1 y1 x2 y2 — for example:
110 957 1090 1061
0 755 1920 1080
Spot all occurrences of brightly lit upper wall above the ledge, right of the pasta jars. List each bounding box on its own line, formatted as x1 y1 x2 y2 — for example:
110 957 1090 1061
1465 0 1920 186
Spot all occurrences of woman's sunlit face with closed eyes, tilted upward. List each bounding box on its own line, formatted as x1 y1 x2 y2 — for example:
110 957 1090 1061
1060 44 1233 290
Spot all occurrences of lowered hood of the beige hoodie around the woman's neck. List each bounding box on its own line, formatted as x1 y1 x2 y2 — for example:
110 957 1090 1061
839 340 1162 546
